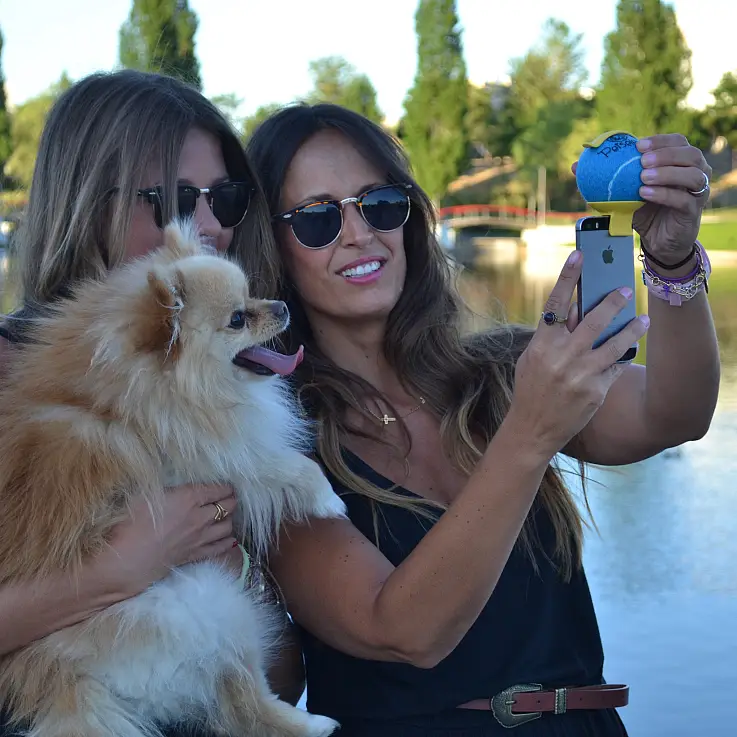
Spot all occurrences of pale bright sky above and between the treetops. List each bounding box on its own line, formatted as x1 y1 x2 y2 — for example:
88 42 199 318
0 0 737 123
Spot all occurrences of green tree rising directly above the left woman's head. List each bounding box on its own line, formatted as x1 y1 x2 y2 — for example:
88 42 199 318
119 0 202 89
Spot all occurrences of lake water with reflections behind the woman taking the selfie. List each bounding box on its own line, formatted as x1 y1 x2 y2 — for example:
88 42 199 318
461 243 737 737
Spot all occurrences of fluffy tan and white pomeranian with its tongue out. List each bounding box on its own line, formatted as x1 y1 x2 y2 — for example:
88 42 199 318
0 223 345 737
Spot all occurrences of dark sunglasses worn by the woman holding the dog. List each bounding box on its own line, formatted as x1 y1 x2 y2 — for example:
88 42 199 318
138 182 253 228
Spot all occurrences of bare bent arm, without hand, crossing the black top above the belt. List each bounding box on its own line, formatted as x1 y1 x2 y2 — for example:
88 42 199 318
271 414 550 667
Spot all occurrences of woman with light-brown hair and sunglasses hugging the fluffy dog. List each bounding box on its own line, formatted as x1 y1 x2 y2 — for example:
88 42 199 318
0 71 303 734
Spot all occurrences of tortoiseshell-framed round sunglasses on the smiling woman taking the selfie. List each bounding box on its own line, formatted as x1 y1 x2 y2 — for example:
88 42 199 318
273 184 412 248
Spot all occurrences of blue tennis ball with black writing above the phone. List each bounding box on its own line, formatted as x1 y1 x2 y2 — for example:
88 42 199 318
576 131 642 202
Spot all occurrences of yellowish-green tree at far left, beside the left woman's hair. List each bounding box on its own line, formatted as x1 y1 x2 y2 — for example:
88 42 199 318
5 72 72 187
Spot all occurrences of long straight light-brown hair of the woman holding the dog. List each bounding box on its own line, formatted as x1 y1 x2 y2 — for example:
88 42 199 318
8 70 276 314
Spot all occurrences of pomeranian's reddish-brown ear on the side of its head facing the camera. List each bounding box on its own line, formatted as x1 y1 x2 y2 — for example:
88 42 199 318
137 267 184 359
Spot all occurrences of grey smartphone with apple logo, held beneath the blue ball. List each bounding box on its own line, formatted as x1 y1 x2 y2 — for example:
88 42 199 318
576 216 638 363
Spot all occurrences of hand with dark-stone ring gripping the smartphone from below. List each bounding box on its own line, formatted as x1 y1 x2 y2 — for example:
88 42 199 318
507 251 650 458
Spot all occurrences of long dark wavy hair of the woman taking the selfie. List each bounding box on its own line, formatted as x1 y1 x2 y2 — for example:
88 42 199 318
247 104 583 578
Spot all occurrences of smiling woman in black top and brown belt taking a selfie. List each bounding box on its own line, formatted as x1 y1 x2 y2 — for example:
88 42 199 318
247 105 719 737
